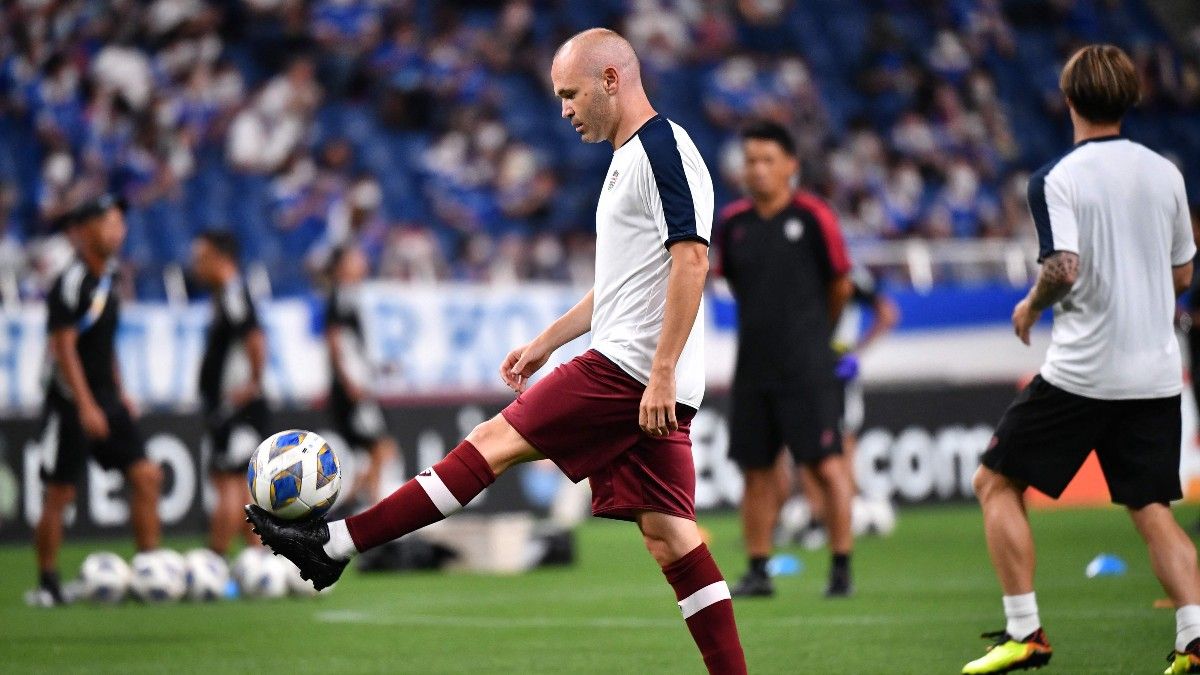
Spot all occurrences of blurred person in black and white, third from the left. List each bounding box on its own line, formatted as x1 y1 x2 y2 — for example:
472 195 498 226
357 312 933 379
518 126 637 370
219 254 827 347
325 245 396 504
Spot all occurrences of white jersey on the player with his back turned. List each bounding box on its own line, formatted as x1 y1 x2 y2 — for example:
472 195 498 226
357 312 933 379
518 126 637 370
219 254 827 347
1028 136 1196 400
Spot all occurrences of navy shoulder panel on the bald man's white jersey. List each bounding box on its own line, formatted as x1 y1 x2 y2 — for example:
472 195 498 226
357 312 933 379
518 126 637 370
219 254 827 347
637 115 708 246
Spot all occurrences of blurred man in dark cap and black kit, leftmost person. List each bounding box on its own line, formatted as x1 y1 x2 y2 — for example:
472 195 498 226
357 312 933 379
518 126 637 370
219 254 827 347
31 196 162 605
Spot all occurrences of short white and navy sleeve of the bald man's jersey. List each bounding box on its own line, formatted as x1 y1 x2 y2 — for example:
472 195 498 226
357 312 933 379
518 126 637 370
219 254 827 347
637 118 713 247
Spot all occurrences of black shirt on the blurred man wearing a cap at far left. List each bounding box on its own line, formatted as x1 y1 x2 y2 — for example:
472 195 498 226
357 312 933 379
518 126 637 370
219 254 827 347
46 259 120 401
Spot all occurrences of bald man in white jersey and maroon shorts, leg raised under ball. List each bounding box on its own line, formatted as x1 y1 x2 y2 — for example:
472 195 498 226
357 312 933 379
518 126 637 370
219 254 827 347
246 29 746 674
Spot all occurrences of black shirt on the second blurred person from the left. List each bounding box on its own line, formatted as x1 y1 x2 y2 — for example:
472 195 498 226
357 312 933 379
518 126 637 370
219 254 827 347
200 276 260 411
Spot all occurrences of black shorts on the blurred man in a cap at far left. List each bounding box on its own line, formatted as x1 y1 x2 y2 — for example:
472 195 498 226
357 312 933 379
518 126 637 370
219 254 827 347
38 386 146 484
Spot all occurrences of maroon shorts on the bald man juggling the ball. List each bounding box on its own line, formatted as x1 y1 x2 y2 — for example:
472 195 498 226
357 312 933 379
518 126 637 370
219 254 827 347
500 350 696 520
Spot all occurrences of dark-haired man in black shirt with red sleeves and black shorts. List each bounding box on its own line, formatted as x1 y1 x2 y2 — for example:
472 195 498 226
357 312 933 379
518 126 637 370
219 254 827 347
718 123 854 597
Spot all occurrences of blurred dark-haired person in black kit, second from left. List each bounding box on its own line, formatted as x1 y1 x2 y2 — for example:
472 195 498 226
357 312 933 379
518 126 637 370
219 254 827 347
192 231 271 555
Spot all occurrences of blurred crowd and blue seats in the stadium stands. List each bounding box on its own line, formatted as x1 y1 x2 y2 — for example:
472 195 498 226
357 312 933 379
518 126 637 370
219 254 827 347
0 0 1200 298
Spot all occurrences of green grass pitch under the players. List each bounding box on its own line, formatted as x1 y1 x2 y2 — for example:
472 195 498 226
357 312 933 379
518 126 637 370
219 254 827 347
0 506 1195 675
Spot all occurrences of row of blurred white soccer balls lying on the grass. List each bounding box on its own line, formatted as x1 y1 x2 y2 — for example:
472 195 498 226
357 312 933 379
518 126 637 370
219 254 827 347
79 546 329 603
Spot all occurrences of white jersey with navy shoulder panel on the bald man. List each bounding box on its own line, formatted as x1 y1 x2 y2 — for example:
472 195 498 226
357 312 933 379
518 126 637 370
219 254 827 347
592 115 714 407
